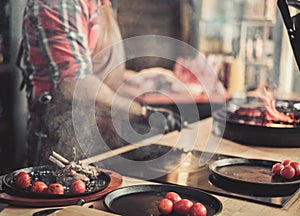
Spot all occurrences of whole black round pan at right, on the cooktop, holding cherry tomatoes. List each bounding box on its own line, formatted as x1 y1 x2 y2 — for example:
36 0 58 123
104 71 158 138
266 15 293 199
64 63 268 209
209 158 300 196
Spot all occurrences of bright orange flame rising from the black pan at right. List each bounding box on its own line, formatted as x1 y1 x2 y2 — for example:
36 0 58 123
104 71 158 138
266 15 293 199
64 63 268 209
257 87 294 123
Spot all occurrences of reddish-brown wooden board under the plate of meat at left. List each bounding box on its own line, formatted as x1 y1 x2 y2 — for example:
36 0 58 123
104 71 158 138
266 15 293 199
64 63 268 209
0 169 123 207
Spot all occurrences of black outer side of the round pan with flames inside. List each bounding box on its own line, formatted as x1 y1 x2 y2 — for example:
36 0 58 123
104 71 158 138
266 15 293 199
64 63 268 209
212 101 300 147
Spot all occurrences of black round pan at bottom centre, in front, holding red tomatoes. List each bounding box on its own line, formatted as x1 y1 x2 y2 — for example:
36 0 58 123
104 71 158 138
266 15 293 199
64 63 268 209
104 185 222 216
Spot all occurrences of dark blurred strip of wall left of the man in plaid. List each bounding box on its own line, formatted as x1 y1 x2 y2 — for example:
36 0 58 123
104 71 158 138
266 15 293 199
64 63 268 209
0 0 27 173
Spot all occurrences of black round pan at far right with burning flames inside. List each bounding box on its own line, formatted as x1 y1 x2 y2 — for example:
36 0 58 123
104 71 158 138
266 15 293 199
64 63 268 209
212 89 300 147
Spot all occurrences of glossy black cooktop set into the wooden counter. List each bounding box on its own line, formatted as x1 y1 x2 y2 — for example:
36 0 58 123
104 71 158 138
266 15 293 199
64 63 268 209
101 144 300 207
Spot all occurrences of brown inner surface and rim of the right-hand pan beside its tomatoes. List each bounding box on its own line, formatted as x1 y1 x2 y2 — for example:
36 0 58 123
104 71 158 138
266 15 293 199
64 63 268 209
209 158 300 187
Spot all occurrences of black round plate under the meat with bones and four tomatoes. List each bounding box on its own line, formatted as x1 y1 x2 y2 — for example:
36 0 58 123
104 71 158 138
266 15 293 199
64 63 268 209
2 166 111 199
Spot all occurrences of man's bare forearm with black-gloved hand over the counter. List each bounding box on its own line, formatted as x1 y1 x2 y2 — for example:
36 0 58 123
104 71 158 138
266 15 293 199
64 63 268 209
60 75 186 133
